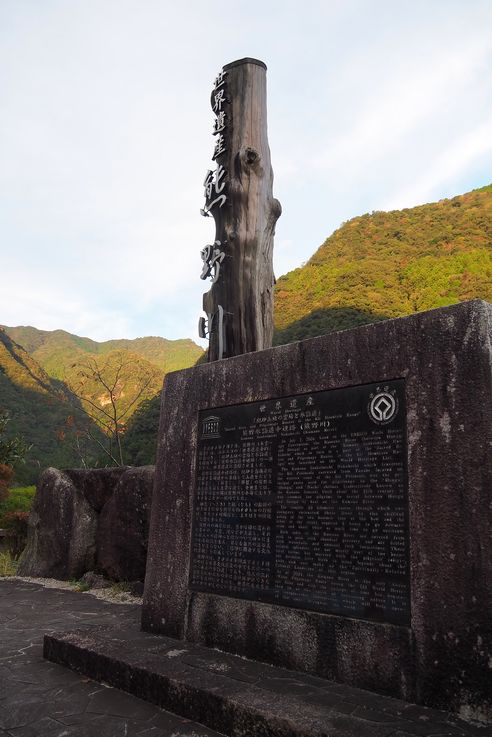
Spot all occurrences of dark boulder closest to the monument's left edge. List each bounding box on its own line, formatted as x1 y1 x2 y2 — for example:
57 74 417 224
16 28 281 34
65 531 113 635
97 466 154 581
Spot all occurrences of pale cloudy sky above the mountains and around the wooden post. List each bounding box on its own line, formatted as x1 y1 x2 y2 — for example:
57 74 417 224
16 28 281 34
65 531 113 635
0 0 492 340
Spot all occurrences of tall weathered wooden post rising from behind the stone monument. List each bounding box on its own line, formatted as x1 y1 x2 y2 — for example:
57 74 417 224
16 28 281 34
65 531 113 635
203 59 282 361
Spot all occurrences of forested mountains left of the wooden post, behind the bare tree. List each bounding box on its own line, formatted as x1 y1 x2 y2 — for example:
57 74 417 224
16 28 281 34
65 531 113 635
0 327 203 483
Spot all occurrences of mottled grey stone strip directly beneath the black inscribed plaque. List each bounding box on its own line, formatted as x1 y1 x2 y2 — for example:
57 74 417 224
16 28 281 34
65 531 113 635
187 593 415 700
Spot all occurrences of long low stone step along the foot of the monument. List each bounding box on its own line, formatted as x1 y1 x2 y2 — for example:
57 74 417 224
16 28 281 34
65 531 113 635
44 627 492 737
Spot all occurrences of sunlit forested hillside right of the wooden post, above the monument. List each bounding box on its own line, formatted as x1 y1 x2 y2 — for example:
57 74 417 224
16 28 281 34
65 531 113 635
275 185 492 345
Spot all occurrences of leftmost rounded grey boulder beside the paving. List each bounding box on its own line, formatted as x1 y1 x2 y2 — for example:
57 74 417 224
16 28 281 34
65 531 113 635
18 468 98 580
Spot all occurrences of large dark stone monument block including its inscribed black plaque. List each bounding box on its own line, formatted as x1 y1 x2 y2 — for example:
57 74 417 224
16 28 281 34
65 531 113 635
142 301 492 720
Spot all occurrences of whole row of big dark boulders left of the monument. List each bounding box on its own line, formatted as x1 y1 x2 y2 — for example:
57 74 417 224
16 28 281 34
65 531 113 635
18 466 154 581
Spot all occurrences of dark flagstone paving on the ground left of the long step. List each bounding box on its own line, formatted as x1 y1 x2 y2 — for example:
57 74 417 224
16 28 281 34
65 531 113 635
0 579 220 737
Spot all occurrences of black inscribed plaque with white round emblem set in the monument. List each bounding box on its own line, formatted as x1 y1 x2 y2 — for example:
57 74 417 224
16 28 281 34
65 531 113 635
190 379 410 625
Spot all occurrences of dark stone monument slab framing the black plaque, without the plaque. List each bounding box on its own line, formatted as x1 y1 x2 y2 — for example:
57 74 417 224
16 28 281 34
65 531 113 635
142 300 492 719
